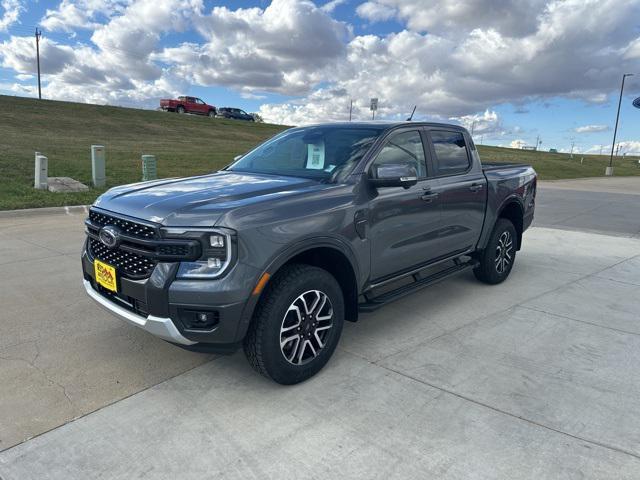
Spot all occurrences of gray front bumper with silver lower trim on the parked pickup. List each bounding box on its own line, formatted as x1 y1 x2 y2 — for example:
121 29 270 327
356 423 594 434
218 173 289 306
82 244 260 353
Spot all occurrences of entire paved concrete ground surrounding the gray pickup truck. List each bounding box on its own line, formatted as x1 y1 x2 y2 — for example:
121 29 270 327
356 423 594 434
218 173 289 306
0 179 640 480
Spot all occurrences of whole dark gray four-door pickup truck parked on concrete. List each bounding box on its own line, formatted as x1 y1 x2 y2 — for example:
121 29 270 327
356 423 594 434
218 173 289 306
82 122 536 384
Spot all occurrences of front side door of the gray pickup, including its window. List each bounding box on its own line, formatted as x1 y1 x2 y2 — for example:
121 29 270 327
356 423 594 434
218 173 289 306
369 129 441 280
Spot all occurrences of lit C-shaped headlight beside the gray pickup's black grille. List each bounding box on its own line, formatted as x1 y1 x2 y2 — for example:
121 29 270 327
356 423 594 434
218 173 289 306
164 228 235 279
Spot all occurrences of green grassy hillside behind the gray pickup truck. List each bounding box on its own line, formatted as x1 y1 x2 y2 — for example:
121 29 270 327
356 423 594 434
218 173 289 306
0 96 640 210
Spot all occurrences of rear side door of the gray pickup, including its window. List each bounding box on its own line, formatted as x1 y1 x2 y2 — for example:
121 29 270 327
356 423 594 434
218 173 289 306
428 128 487 255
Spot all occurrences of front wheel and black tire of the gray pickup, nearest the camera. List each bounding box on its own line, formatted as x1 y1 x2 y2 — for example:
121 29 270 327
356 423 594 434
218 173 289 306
244 264 344 385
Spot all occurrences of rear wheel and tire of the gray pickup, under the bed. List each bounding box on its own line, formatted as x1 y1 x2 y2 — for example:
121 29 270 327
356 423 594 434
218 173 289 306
473 218 517 285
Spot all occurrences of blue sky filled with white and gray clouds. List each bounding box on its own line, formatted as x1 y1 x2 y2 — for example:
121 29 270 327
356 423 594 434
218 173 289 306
0 0 640 153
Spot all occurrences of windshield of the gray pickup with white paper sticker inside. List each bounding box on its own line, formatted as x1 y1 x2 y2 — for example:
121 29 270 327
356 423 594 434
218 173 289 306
227 125 382 182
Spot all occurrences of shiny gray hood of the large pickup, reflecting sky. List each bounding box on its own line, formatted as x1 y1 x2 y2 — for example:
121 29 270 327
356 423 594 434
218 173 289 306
94 171 318 227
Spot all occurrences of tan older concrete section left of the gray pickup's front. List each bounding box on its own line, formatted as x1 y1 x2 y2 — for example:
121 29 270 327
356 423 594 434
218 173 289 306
0 211 211 450
